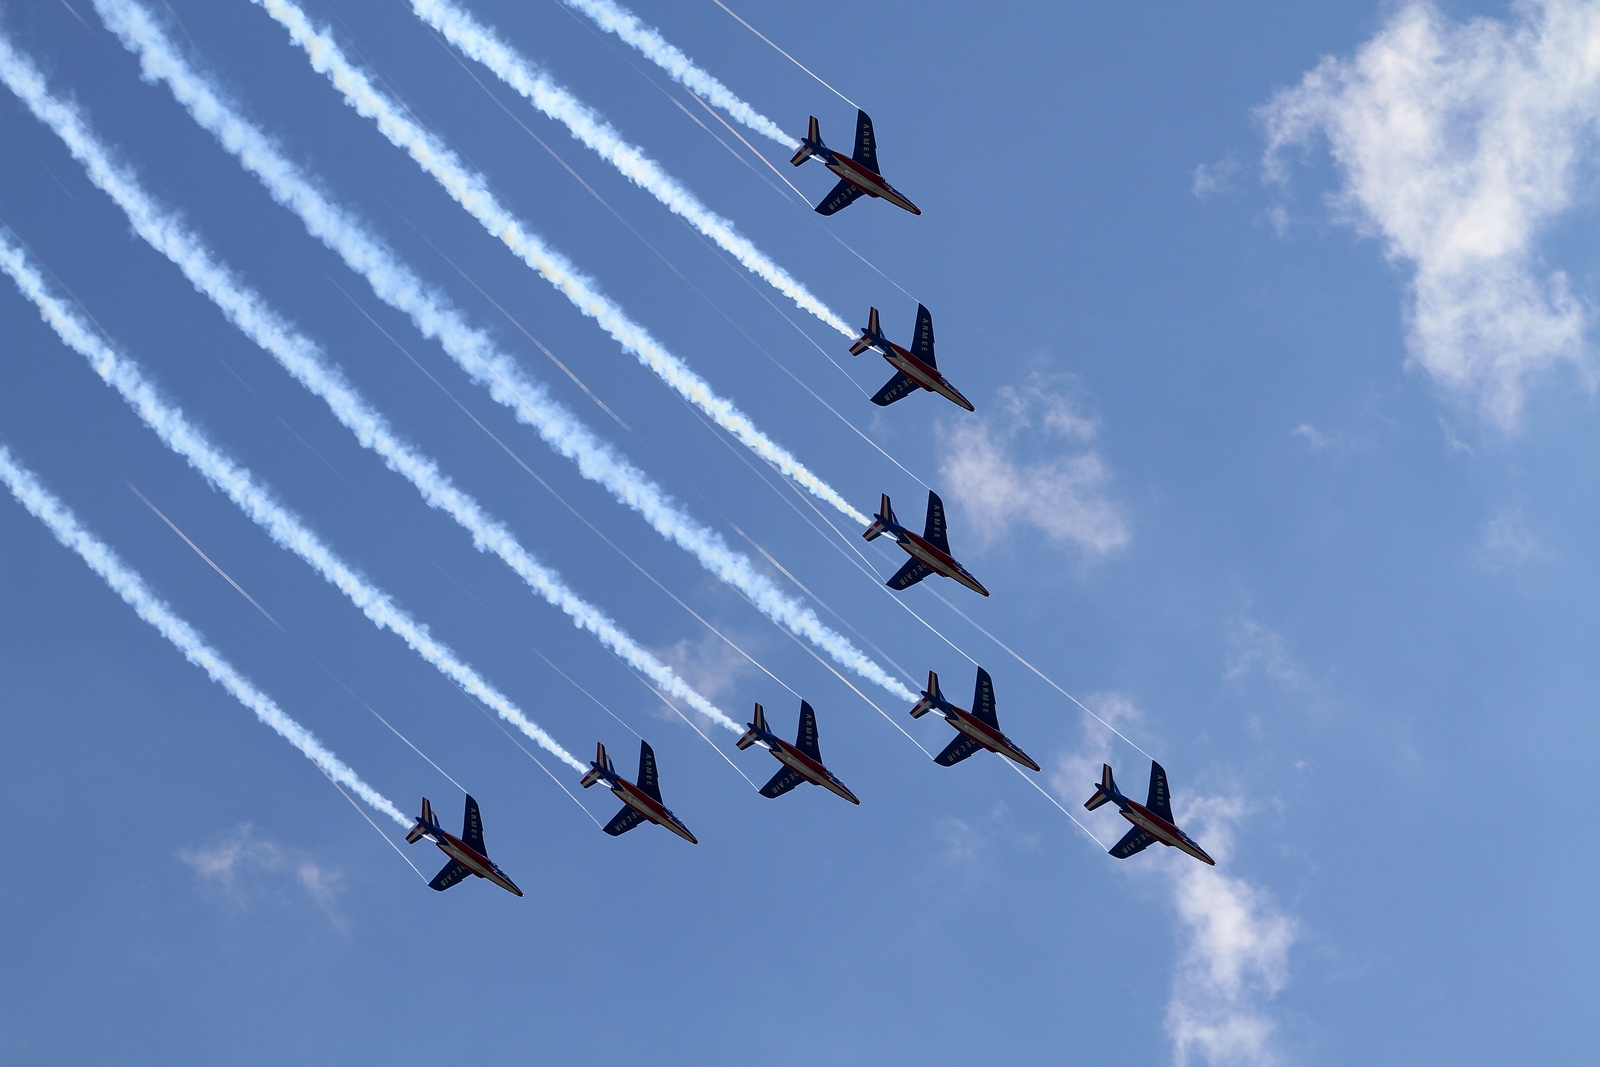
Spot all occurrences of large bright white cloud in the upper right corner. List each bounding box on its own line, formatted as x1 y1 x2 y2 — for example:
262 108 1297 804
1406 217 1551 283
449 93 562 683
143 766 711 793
1259 0 1600 430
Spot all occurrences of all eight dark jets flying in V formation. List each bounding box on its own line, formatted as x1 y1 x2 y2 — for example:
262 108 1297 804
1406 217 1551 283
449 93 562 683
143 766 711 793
406 110 1216 896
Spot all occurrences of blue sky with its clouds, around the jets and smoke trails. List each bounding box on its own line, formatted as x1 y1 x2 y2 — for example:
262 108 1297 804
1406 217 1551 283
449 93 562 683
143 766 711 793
0 0 1600 1067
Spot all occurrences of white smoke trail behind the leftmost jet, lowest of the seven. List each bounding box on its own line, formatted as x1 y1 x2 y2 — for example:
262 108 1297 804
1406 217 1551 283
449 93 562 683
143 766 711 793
0 445 411 829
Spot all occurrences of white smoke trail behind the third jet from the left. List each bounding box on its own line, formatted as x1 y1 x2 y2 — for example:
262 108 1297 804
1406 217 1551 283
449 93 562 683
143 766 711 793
0 37 738 748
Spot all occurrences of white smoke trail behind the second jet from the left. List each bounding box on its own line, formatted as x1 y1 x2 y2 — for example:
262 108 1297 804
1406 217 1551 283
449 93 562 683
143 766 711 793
0 231 589 771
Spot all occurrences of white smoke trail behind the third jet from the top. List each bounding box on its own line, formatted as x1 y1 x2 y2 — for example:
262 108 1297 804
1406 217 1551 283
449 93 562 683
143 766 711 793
251 0 869 525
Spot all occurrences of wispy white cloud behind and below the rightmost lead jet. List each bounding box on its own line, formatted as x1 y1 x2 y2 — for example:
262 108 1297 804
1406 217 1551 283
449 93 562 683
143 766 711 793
1051 693 1296 1067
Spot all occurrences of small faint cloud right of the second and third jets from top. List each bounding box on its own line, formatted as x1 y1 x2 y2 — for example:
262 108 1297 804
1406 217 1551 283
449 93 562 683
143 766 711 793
939 374 1130 557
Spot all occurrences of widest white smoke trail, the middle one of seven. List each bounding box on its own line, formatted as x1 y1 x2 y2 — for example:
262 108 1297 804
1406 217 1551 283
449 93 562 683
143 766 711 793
96 0 915 710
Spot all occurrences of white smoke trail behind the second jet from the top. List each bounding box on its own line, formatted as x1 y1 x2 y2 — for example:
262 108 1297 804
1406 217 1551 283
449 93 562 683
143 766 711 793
411 0 856 339
